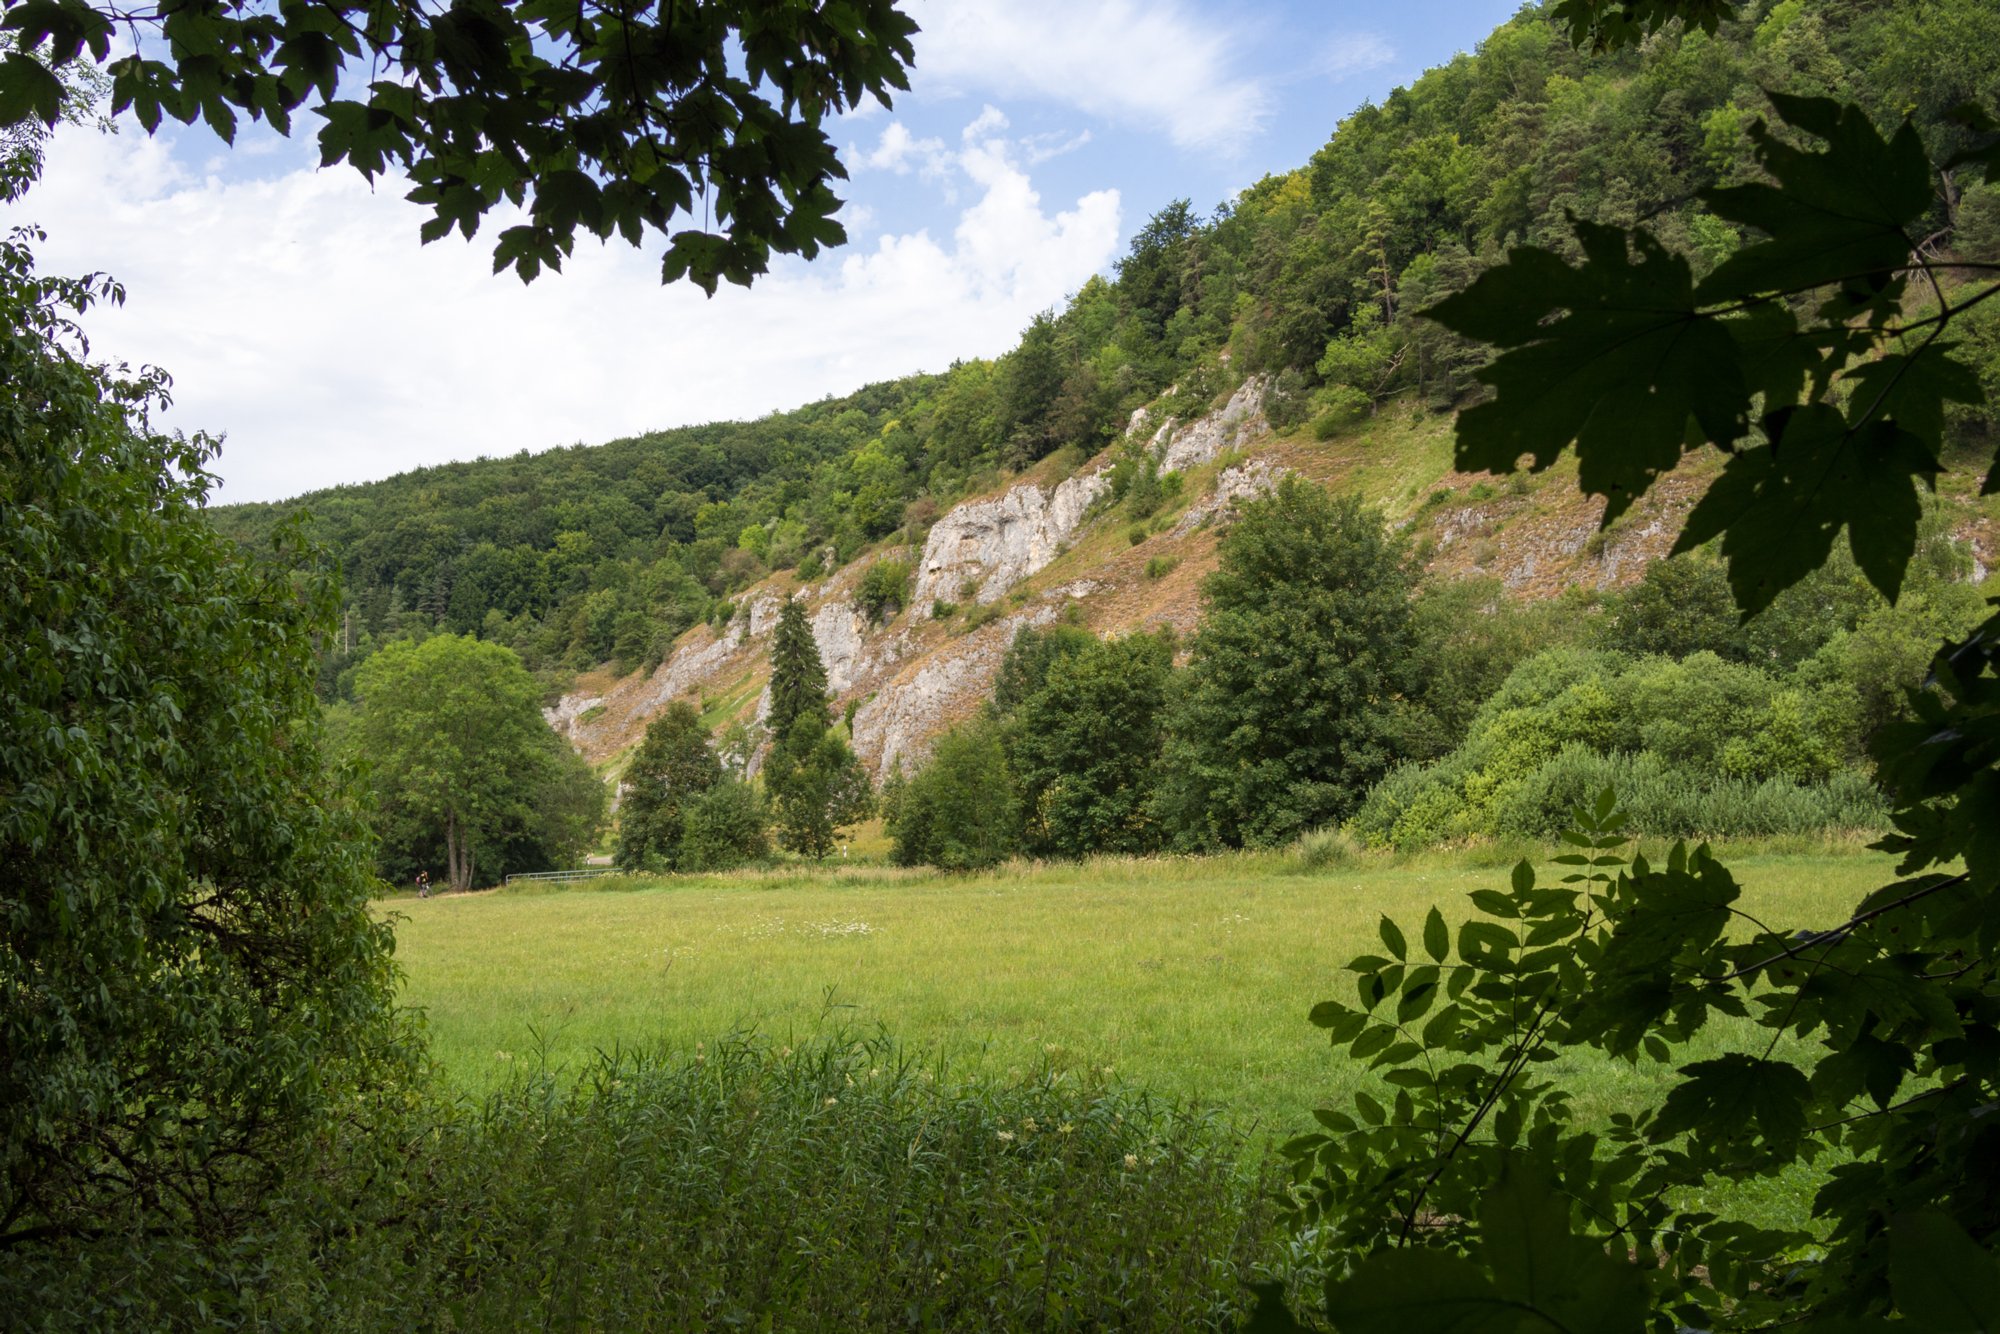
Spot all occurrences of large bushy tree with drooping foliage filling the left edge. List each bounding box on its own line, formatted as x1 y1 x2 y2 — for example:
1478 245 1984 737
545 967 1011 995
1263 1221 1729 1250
0 222 406 1252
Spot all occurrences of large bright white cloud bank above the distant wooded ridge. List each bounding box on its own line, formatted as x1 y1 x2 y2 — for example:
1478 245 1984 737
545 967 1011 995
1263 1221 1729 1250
6 117 1120 500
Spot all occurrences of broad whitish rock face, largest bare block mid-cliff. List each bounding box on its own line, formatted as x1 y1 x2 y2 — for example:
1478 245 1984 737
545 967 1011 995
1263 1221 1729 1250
910 472 1110 620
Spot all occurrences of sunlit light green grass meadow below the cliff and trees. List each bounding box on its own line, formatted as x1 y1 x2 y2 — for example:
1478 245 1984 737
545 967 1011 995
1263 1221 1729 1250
384 846 1890 1138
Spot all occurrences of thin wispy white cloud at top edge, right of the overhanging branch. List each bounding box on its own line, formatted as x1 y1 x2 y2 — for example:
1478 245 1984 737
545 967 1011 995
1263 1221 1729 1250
910 0 1270 152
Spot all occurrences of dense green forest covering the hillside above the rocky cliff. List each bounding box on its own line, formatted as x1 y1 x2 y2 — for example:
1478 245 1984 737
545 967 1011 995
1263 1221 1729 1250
216 0 2000 696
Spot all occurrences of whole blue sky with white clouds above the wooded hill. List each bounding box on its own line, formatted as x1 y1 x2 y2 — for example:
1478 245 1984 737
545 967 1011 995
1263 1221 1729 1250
4 0 1518 500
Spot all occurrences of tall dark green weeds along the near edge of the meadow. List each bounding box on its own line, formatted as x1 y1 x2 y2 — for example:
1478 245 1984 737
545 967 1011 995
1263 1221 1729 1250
0 1038 1274 1332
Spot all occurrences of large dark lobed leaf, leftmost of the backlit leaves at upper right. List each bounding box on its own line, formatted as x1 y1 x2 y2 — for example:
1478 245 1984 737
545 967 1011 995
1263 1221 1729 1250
1424 222 1750 526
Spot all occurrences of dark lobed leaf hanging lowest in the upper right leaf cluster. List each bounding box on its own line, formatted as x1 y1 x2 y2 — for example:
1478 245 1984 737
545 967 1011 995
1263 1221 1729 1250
1674 404 1938 618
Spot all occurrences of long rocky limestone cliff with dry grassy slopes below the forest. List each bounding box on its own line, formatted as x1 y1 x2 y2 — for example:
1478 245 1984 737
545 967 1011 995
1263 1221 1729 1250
548 376 1824 776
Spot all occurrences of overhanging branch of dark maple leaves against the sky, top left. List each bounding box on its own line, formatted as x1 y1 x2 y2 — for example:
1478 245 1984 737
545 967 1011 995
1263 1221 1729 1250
0 0 916 292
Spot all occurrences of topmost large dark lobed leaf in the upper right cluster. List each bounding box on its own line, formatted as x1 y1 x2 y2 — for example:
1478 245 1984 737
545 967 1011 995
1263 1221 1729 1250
1698 92 1932 306
